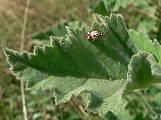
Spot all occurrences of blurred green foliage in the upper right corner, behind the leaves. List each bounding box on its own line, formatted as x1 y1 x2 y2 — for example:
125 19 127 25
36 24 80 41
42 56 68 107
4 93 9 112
89 0 160 36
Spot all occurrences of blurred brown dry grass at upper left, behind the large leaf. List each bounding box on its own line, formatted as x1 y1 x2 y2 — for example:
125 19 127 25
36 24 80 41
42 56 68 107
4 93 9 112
0 0 88 48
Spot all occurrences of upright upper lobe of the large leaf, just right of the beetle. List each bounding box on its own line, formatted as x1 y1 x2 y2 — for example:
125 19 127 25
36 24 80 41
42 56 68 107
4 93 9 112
92 14 138 65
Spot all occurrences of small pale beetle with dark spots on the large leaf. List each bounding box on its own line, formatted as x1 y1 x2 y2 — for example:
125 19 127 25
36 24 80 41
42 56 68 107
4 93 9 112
85 31 103 41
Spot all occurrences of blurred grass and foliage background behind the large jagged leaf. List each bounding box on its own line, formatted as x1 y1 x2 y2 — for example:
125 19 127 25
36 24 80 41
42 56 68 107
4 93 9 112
0 0 161 120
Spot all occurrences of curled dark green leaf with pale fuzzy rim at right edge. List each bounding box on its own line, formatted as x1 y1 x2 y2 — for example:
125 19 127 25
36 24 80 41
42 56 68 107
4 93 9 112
127 52 161 91
